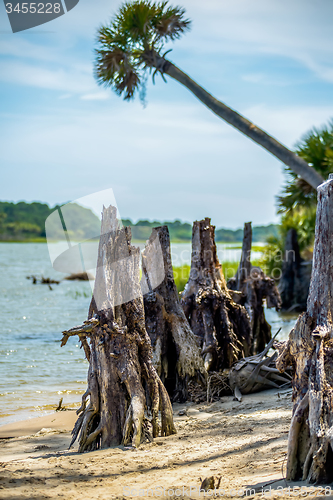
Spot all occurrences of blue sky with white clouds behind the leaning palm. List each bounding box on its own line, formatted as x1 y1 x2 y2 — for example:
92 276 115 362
0 0 333 228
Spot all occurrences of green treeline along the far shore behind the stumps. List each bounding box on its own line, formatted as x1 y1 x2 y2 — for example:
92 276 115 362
0 201 278 243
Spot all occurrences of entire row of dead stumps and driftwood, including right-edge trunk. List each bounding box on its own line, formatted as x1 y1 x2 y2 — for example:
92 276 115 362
58 188 333 483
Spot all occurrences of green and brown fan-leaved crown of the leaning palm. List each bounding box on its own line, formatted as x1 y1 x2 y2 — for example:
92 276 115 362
95 0 190 99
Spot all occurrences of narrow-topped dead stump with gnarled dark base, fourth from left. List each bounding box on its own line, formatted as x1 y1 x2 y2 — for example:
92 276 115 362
228 222 281 354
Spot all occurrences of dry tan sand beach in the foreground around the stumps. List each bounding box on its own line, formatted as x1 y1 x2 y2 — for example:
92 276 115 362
0 390 333 500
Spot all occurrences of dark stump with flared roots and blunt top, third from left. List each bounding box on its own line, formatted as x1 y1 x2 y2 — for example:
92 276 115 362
181 218 251 370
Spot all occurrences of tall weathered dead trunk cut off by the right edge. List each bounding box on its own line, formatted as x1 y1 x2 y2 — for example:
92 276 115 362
277 175 333 483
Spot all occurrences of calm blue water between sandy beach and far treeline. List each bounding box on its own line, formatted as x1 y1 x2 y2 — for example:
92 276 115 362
0 243 295 425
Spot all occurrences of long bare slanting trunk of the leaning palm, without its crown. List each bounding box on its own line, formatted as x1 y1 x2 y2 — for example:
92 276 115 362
159 58 324 188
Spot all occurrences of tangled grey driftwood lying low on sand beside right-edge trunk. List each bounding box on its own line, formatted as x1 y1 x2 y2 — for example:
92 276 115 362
229 330 292 399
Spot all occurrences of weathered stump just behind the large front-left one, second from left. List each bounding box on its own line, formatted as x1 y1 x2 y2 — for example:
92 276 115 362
142 226 205 402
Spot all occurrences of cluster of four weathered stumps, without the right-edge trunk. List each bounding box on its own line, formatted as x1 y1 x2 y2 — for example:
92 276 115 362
62 206 279 451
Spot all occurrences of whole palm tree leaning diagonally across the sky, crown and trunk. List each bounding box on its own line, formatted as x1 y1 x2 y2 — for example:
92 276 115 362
95 0 323 188
